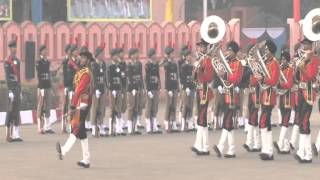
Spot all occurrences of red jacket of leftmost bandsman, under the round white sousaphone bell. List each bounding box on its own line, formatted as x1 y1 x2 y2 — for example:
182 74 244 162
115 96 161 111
196 58 214 101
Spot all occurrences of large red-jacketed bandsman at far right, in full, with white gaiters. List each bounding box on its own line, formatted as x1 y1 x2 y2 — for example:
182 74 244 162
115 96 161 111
295 39 319 163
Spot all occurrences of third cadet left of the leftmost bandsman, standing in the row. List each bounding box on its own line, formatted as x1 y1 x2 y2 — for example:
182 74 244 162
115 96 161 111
145 48 161 133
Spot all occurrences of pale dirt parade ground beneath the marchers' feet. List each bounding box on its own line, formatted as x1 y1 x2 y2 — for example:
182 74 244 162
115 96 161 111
0 105 320 180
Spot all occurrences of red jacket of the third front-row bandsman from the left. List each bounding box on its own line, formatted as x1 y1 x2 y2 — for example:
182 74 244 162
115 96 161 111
261 58 280 106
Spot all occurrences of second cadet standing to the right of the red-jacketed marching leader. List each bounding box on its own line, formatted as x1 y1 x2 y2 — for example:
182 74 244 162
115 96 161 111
107 49 121 135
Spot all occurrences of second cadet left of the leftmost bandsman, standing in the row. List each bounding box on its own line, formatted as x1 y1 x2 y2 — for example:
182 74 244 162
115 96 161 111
163 47 179 132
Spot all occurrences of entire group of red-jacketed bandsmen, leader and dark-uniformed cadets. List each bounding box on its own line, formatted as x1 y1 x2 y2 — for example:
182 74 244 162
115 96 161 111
1 34 320 168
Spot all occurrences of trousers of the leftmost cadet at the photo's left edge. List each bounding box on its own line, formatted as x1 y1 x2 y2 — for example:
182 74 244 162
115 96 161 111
5 86 21 127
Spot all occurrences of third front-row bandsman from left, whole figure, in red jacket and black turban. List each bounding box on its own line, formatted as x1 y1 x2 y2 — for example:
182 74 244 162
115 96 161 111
255 40 280 160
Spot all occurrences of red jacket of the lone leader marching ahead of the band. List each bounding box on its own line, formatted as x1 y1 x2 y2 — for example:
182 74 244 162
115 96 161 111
71 67 93 106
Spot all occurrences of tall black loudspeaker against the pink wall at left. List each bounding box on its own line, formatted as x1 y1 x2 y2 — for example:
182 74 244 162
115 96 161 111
25 41 36 79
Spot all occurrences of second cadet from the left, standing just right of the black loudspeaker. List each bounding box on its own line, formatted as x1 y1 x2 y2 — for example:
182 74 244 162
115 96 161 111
36 45 54 134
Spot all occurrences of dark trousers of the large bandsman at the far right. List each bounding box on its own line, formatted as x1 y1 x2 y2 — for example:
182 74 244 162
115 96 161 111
298 91 312 134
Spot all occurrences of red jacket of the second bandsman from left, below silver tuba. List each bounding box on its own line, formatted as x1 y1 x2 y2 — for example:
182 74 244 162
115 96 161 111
225 59 243 106
